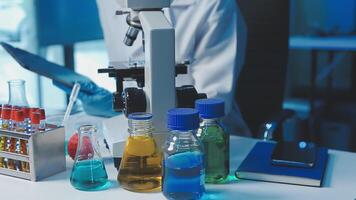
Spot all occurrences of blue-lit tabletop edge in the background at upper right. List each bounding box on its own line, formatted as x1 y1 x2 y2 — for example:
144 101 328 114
289 36 356 51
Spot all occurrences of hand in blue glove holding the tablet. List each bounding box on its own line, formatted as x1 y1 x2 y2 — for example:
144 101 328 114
52 80 119 117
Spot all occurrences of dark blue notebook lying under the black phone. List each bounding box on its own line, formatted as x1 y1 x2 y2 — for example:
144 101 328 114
236 142 328 187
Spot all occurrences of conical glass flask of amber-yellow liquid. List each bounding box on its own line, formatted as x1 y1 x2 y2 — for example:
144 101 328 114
117 113 162 192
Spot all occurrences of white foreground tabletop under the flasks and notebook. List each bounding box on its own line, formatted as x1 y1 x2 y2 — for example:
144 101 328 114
0 136 356 200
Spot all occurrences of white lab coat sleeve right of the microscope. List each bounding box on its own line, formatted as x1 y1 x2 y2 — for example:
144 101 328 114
190 0 241 114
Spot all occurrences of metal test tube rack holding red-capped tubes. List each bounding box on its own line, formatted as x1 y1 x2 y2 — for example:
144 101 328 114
0 125 66 181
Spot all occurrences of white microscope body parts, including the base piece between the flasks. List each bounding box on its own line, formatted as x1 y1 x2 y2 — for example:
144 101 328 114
104 0 176 157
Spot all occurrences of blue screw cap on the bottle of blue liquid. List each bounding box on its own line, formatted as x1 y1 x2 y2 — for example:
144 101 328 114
167 108 199 131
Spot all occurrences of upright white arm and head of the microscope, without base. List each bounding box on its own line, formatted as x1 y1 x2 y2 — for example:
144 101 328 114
118 0 176 133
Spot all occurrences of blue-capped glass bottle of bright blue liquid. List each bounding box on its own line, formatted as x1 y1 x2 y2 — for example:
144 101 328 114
162 108 205 199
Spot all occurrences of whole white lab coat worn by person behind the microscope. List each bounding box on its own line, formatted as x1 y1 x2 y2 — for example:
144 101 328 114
97 0 250 135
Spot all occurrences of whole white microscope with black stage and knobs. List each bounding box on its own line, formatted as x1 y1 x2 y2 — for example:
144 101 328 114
98 0 206 166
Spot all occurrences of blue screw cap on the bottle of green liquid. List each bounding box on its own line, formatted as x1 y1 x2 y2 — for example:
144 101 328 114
195 98 225 119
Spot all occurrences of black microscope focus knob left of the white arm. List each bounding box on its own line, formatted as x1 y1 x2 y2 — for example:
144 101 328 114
123 88 147 116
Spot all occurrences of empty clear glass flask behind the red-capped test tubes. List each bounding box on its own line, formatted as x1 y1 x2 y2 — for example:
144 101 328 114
7 79 28 107
